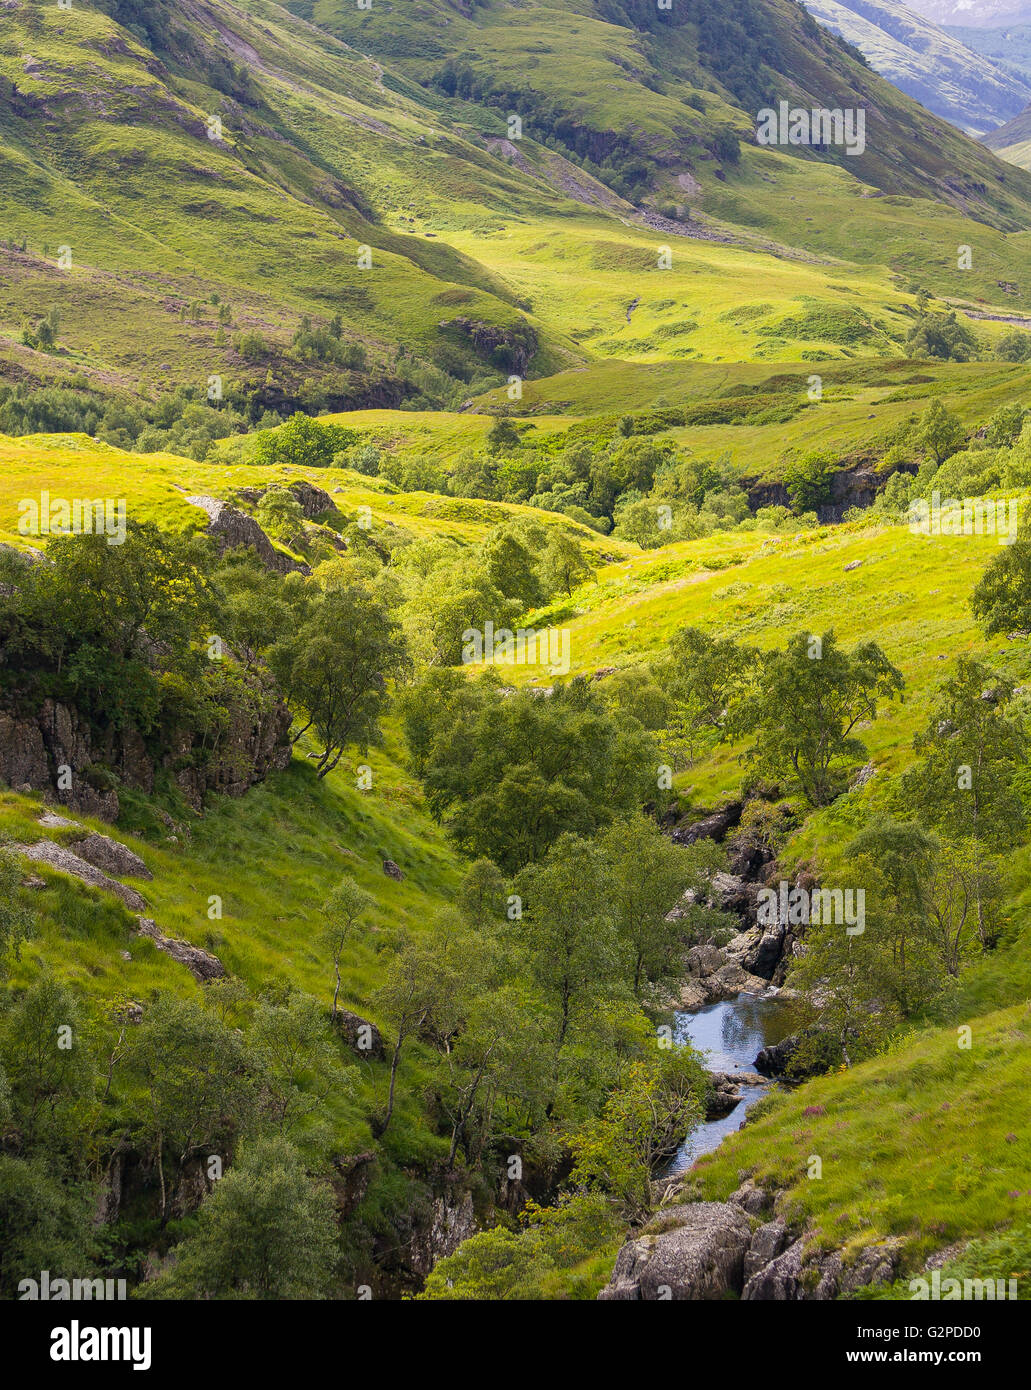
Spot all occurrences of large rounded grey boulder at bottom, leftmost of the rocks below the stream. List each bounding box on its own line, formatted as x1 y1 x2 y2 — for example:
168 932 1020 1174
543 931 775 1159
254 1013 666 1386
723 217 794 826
597 1202 752 1302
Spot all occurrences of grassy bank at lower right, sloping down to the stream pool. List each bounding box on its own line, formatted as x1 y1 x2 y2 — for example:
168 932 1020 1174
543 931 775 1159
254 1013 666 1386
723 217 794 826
692 995 1031 1273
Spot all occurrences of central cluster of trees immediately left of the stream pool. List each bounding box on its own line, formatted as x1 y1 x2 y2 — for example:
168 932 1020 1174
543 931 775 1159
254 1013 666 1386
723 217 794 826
375 813 731 1189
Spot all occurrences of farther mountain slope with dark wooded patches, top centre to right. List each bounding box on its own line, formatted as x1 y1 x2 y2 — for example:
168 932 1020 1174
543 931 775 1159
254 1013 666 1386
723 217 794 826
301 0 1027 219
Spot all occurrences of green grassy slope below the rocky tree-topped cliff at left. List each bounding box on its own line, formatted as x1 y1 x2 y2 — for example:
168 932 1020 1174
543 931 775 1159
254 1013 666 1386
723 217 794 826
0 744 460 1163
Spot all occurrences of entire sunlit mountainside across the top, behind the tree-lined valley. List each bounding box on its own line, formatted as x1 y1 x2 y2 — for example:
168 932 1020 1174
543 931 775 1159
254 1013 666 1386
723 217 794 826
0 0 1031 418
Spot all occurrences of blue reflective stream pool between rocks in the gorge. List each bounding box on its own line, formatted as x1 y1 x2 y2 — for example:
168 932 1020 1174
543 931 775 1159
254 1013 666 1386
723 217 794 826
667 994 792 1173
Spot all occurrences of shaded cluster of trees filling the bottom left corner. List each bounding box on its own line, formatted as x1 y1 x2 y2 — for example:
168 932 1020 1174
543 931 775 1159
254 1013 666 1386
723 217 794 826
0 961 354 1298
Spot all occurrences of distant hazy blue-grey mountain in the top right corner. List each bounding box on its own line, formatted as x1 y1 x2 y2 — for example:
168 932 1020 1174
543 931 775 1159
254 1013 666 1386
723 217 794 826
806 0 1031 135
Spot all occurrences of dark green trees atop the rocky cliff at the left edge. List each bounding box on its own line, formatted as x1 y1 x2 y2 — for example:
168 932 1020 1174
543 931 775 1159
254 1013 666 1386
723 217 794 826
0 521 409 776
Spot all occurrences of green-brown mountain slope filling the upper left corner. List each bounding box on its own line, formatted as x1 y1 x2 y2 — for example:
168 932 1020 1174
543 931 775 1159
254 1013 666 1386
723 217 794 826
0 0 580 403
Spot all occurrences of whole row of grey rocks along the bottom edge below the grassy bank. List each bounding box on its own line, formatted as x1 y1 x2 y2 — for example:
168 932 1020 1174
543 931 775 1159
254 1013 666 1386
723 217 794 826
597 1180 902 1302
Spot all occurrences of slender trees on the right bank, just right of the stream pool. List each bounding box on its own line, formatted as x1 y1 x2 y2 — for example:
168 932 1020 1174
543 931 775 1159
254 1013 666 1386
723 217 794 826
792 657 1028 1072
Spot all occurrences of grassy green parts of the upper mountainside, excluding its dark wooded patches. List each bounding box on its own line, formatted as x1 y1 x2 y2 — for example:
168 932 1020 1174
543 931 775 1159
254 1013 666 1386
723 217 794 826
0 0 1031 405
